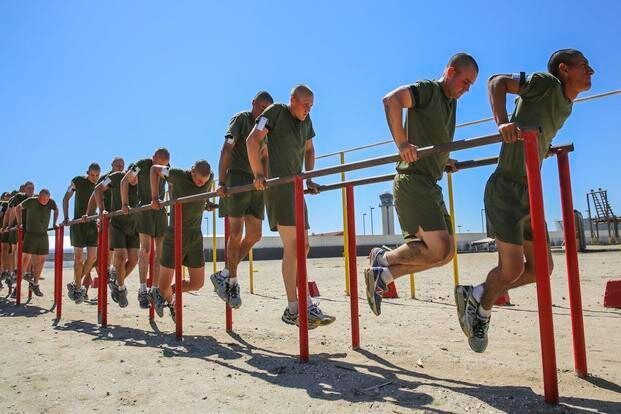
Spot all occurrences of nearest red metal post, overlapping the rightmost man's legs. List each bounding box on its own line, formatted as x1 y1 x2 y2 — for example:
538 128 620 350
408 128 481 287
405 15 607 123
522 130 558 404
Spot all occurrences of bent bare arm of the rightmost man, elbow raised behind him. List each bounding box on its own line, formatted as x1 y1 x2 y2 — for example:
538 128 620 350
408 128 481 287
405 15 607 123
487 72 526 143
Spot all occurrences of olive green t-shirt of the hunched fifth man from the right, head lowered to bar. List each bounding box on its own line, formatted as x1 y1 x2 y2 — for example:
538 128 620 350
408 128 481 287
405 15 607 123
162 168 211 232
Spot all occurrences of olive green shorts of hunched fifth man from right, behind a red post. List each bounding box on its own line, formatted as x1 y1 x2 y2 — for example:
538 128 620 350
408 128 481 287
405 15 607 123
160 227 205 269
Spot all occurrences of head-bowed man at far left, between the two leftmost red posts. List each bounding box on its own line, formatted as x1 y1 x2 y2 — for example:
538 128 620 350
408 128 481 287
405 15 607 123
16 189 58 296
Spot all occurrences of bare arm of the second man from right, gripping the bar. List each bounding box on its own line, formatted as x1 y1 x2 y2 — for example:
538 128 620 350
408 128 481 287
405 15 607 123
383 86 418 162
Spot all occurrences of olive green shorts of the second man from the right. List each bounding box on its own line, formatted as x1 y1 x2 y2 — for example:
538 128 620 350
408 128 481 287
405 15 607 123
393 174 453 242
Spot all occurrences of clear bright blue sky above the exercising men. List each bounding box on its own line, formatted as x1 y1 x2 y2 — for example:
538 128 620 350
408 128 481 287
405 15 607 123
0 0 621 233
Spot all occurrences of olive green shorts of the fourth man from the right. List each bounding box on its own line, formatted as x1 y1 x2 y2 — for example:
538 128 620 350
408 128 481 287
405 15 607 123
218 170 265 220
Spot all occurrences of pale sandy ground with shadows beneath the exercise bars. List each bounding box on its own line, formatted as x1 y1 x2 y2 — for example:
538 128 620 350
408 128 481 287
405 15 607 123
0 250 621 413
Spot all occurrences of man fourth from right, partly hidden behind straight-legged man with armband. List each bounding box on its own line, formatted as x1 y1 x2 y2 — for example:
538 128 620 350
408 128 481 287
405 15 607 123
210 91 274 309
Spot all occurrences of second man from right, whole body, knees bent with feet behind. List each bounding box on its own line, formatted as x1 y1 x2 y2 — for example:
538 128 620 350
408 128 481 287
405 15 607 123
364 53 479 315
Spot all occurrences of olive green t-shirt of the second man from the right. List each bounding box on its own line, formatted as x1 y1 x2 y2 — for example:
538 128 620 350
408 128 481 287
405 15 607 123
397 80 457 180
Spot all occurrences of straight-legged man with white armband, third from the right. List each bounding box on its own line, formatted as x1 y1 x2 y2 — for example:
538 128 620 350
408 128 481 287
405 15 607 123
246 85 335 329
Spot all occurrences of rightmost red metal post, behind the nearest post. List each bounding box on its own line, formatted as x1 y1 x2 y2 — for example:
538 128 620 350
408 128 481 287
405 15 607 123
556 150 588 378
